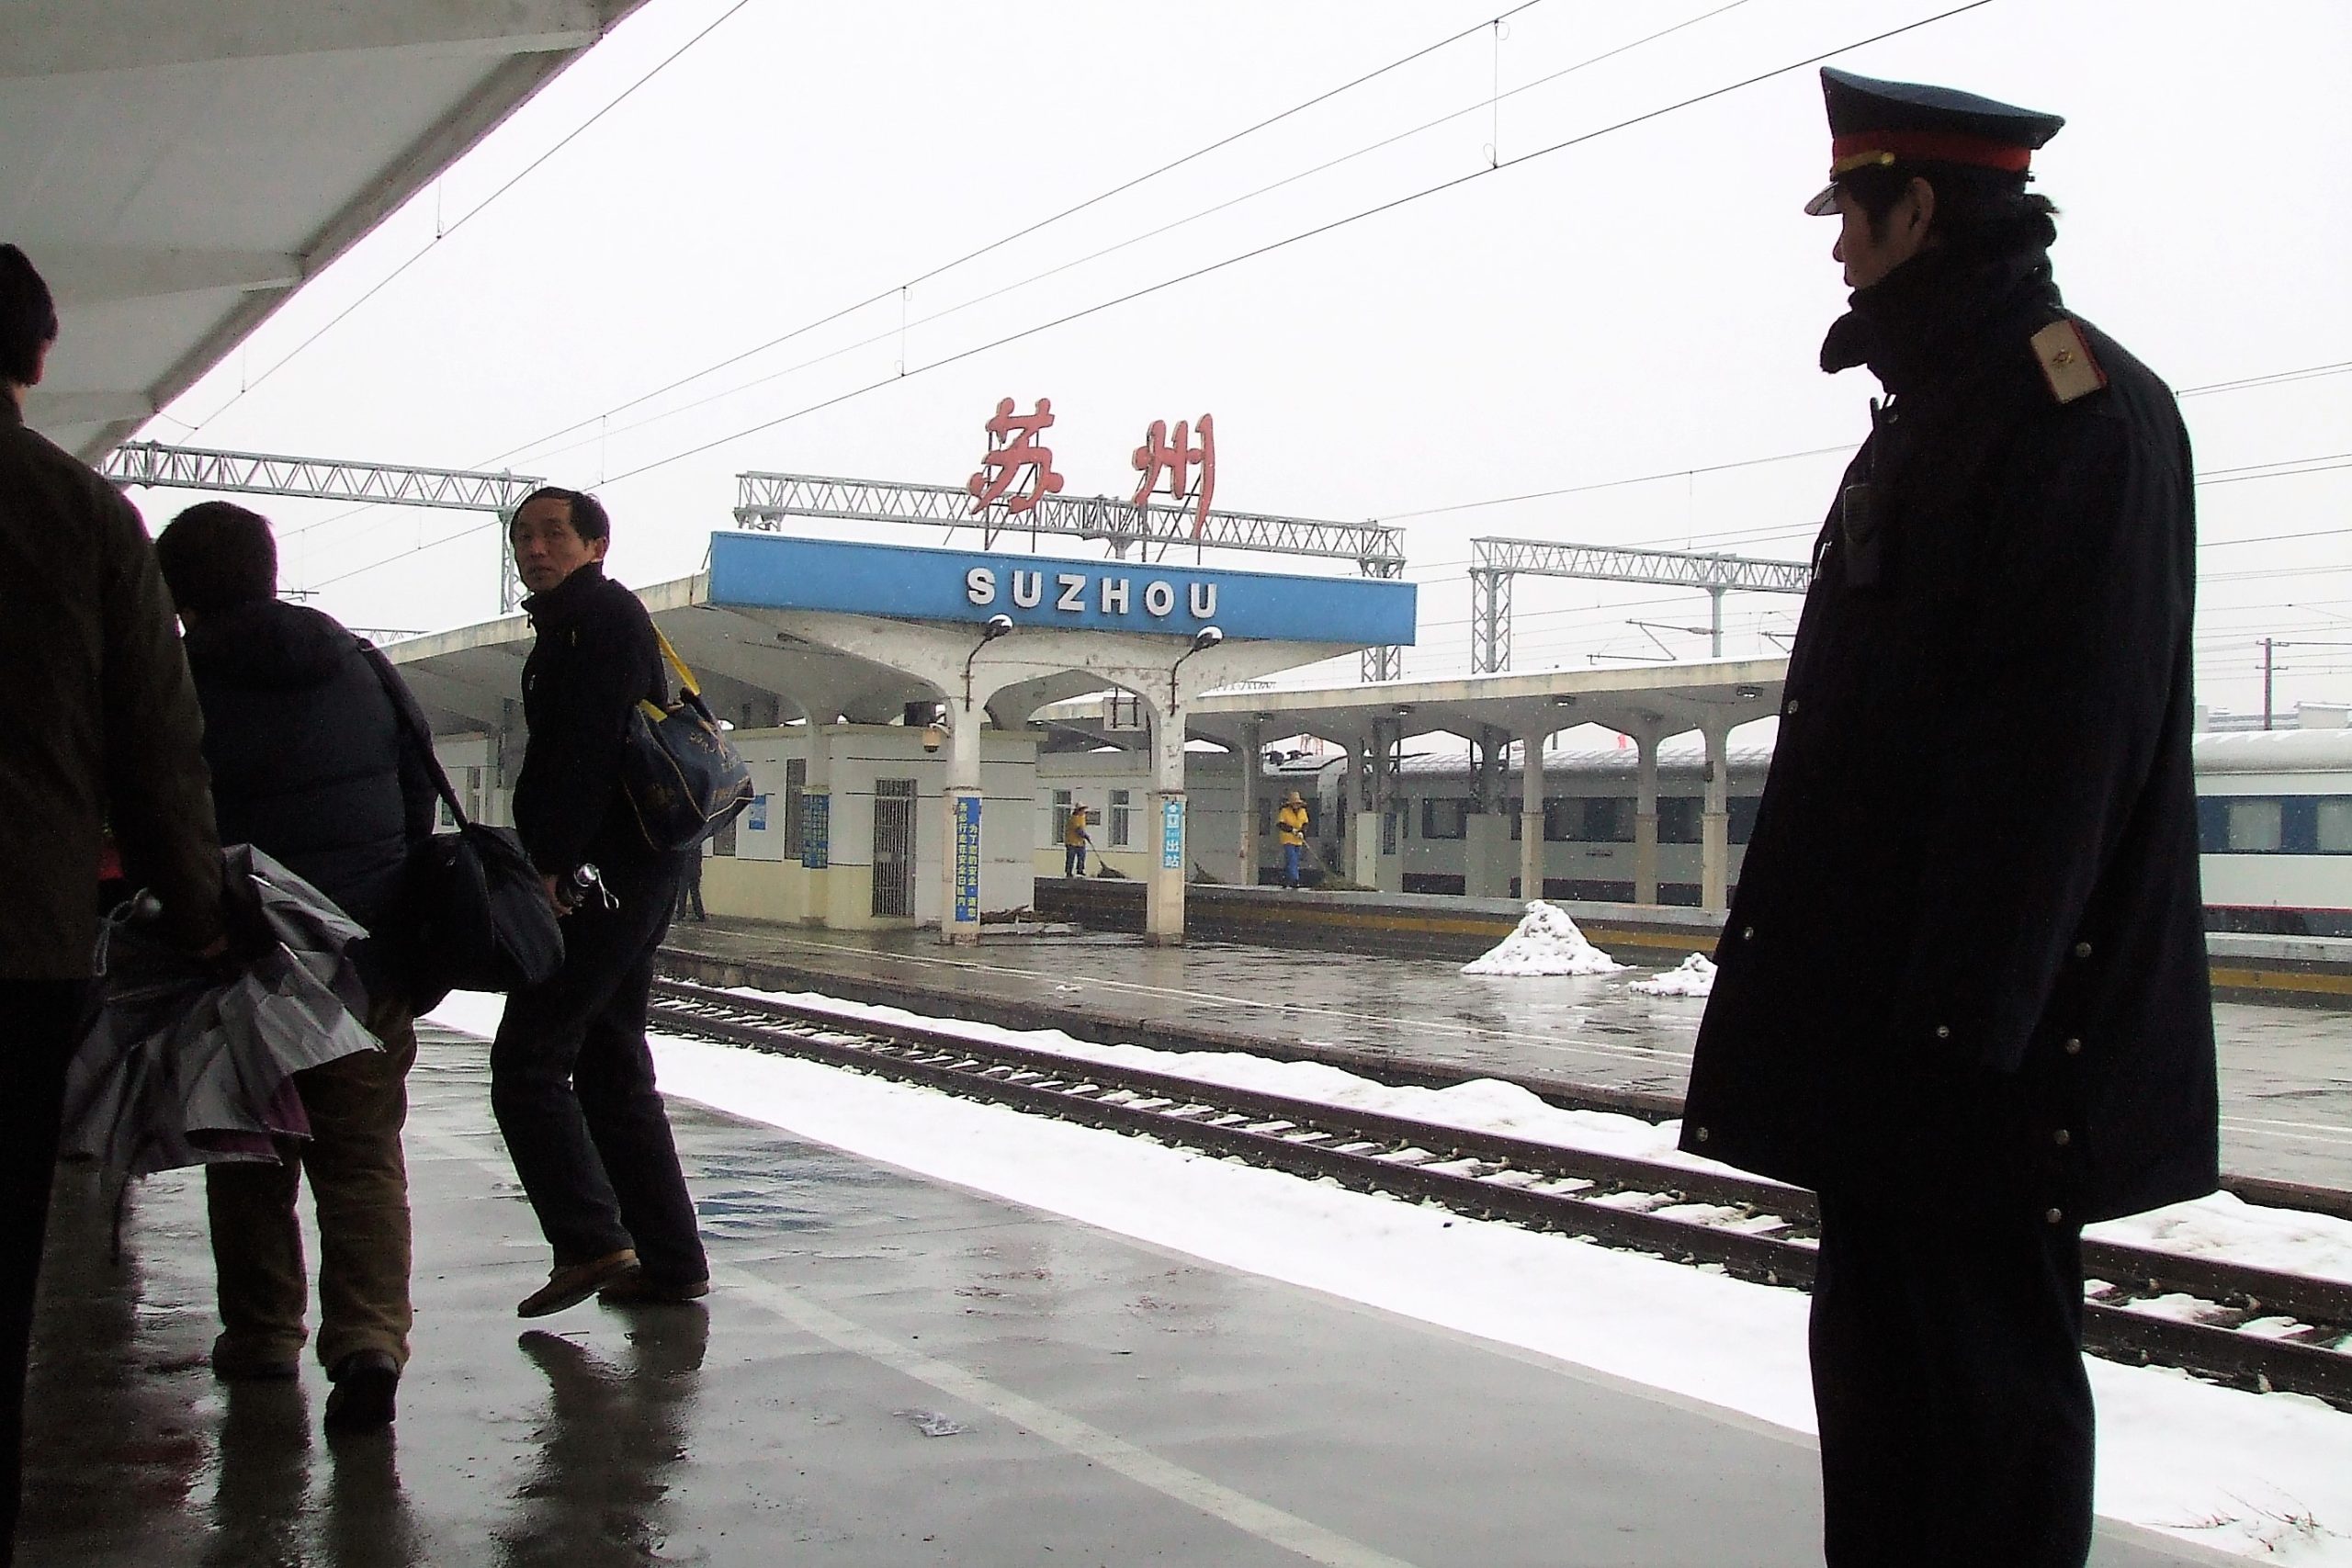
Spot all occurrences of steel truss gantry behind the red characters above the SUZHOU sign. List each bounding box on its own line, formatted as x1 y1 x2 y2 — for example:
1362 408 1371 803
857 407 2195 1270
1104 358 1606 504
736 472 1404 682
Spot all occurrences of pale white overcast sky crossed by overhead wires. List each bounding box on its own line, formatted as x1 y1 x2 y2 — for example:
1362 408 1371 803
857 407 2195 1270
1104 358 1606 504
136 0 2352 707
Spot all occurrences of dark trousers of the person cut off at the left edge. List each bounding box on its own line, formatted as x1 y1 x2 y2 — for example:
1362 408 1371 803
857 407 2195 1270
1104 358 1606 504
0 980 87 1565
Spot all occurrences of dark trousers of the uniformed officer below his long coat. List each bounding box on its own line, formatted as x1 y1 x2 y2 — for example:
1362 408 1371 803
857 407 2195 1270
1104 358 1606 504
1811 1194 2093 1568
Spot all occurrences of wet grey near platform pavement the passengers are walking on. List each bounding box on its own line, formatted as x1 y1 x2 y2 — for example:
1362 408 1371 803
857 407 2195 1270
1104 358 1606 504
18 1032 2227 1568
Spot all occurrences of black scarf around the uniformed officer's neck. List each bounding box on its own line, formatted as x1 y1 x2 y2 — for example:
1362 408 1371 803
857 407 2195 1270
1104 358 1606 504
1820 244 2061 398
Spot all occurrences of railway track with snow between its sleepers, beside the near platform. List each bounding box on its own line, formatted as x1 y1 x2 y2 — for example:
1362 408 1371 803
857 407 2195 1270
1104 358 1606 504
654 980 2352 1411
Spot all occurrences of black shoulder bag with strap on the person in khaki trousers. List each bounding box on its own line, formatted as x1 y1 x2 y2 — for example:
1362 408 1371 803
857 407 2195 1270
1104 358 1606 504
365 647 564 1013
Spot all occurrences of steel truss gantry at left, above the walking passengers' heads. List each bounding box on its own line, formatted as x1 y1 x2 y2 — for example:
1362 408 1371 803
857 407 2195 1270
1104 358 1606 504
106 442 546 614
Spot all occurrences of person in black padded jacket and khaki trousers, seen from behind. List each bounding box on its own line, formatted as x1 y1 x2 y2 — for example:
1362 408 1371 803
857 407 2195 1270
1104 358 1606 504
155 501 435 1429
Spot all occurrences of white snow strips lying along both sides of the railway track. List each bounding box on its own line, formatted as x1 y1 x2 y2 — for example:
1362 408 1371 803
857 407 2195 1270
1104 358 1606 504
435 997 2352 1568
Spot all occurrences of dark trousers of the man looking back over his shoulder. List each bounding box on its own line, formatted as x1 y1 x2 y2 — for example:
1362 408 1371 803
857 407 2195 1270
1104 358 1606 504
489 863 710 1281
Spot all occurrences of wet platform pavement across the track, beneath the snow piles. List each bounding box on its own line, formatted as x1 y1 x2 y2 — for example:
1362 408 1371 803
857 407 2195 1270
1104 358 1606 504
671 919 2352 1190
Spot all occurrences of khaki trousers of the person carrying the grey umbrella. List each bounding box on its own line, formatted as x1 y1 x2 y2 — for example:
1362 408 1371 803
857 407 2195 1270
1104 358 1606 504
205 999 416 1368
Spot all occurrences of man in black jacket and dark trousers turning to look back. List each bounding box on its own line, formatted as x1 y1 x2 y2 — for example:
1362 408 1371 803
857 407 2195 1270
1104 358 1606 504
489 489 710 1316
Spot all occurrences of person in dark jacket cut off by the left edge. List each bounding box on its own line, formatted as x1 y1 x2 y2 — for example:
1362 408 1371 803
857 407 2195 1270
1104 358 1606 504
0 244 226 1565
